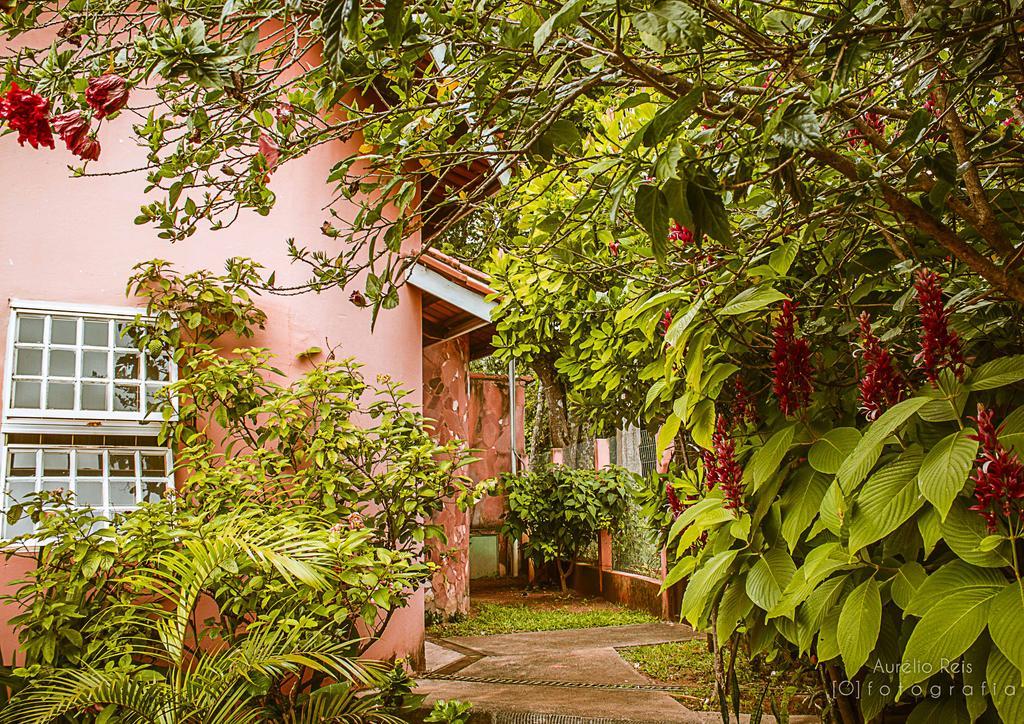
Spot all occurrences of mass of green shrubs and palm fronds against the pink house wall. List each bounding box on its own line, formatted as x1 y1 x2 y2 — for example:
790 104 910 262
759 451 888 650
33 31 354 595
2 260 473 724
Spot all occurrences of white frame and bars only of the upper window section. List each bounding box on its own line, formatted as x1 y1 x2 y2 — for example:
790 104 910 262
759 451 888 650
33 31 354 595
2 299 177 434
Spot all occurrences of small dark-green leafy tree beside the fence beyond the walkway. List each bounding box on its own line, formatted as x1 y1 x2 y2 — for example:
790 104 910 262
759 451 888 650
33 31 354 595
502 466 633 593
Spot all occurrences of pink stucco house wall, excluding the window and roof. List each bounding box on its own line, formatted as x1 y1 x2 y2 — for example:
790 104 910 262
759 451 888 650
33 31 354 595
0 83 423 655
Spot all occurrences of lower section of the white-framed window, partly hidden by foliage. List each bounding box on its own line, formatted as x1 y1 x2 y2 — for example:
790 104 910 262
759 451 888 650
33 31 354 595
3 433 174 539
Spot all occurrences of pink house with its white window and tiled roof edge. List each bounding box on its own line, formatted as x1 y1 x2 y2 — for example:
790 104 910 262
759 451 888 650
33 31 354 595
0 87 521 661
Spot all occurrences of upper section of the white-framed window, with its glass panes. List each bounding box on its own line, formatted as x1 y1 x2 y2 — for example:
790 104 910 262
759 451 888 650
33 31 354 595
4 303 175 420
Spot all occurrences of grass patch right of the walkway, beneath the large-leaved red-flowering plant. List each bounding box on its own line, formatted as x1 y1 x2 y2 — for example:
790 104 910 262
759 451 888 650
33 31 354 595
618 639 815 714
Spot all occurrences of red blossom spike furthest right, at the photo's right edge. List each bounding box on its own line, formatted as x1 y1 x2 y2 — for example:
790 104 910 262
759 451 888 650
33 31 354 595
971 404 1024 533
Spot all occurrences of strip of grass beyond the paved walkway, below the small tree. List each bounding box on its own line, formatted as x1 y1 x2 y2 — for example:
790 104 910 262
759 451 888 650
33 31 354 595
427 599 657 637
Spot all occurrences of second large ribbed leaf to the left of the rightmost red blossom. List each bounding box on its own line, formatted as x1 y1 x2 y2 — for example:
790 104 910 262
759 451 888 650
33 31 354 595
849 449 923 553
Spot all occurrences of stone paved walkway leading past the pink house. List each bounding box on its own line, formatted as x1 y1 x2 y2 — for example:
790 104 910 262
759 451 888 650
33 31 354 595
418 624 798 724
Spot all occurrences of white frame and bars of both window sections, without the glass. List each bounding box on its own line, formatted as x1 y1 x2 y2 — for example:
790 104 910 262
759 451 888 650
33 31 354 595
0 299 178 546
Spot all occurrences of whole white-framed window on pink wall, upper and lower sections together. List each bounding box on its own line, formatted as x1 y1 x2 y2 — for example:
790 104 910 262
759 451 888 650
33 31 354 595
0 300 177 539
